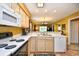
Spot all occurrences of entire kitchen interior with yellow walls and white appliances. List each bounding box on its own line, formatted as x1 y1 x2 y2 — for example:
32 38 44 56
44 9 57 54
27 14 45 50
0 3 79 56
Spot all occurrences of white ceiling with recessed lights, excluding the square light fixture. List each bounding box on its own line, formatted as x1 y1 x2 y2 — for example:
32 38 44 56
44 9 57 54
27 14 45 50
25 3 79 24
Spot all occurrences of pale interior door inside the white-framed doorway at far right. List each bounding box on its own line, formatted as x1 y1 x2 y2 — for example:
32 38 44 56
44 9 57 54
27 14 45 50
70 21 78 44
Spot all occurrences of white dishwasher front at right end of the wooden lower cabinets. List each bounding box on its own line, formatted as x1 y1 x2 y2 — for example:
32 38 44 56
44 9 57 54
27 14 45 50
54 37 66 52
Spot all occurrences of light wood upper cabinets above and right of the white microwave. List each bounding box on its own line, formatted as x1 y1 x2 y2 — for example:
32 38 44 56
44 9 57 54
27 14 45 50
11 3 29 28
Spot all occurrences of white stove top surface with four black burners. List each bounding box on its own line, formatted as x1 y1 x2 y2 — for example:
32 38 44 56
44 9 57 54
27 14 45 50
0 38 25 56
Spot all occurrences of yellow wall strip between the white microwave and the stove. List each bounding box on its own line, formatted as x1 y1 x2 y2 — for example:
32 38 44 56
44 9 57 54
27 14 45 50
0 26 22 36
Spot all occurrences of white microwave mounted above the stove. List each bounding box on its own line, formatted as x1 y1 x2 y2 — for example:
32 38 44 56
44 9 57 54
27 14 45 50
0 6 20 26
